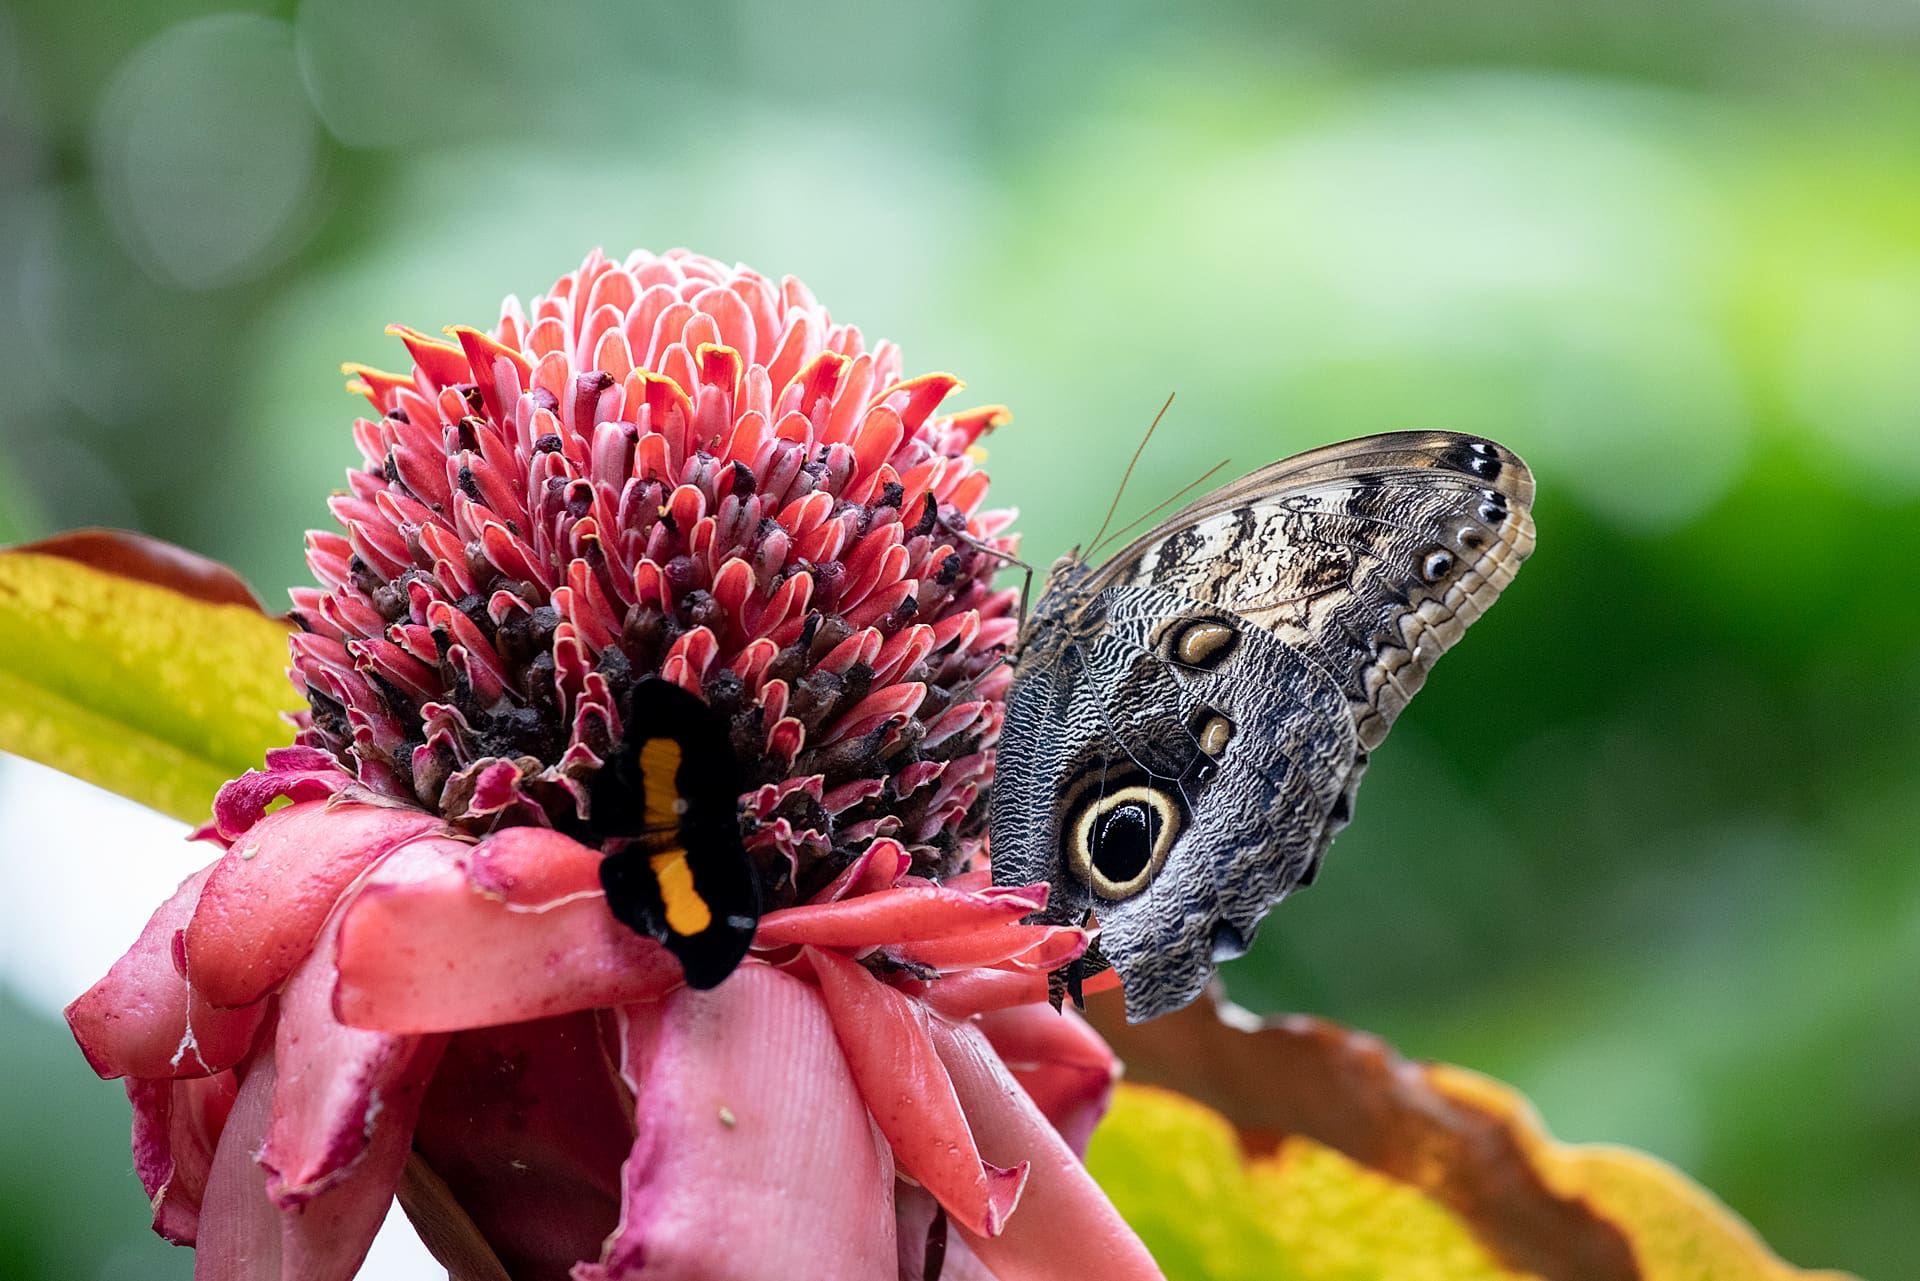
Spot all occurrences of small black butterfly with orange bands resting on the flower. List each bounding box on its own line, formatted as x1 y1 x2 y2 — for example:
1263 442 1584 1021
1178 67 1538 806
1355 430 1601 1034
591 680 760 987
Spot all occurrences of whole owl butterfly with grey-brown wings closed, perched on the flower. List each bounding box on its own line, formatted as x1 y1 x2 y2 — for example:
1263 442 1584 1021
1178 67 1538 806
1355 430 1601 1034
991 432 1534 1022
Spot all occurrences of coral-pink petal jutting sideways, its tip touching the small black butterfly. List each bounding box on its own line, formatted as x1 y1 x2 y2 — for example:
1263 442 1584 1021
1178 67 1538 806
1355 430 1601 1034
334 837 682 1033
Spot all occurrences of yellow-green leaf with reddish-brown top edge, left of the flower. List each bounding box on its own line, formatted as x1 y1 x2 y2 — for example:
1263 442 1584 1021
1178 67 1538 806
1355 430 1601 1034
0 532 301 822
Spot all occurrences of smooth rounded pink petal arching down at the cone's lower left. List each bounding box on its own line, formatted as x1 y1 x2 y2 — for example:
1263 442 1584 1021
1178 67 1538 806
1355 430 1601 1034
186 801 440 1006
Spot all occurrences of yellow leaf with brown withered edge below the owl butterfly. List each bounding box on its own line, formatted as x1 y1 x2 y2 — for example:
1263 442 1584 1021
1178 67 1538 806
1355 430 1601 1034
1087 999 1841 1281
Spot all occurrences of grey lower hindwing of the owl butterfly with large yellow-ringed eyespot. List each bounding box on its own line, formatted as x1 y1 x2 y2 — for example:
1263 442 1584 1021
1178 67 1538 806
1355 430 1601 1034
993 588 1359 1022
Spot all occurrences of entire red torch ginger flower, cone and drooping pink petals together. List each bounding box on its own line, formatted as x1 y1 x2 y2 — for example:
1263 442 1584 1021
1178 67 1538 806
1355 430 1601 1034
67 252 1160 1281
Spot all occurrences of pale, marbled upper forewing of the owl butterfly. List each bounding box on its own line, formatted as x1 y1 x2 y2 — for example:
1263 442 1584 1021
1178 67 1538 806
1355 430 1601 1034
1091 432 1534 749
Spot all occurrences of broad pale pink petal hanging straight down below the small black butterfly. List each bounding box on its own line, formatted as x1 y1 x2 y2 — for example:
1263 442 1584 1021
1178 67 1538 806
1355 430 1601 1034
574 962 895 1281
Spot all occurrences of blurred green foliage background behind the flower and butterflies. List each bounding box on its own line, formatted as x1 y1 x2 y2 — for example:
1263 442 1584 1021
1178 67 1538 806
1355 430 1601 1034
0 0 1920 1277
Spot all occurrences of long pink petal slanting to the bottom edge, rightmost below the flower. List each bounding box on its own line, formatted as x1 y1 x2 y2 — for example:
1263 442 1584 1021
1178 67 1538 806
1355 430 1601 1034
929 1020 1164 1281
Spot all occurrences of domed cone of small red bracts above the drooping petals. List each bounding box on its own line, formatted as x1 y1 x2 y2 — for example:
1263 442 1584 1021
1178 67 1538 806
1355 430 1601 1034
294 255 1018 871
